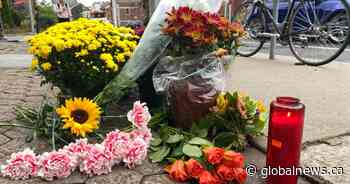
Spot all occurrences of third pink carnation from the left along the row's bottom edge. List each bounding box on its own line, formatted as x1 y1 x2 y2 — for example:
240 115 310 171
80 144 113 176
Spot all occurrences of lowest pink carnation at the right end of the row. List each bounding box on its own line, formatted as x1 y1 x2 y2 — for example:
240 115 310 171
123 138 148 168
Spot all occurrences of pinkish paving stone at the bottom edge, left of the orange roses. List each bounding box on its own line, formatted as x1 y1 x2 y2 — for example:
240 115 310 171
86 167 143 184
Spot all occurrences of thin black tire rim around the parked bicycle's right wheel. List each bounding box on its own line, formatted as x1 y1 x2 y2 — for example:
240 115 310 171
288 0 350 66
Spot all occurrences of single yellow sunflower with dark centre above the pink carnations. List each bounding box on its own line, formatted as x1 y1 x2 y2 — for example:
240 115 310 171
56 98 101 137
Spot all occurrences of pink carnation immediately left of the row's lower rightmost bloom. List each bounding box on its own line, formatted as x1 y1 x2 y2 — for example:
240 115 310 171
102 130 130 164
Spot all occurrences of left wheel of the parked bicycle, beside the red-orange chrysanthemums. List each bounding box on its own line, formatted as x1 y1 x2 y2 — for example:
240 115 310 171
235 1 266 57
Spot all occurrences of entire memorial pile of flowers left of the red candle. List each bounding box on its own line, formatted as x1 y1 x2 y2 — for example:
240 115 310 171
0 0 266 184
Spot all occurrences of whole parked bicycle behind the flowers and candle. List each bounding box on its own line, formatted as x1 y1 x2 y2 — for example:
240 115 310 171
235 0 350 66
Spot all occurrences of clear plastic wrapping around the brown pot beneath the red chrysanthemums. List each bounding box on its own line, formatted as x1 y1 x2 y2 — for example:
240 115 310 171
153 54 226 128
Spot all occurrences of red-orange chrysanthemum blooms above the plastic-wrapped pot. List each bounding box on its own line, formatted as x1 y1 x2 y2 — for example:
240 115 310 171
162 7 244 56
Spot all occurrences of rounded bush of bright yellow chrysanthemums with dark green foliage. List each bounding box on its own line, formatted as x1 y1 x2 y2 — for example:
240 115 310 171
28 19 139 98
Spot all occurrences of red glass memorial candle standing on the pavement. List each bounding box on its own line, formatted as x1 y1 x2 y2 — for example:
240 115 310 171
266 97 305 184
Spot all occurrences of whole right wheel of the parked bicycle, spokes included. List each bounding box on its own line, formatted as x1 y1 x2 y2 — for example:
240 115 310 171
289 0 350 66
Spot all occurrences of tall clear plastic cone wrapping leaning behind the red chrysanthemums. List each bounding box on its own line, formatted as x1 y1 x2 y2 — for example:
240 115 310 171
95 0 223 104
